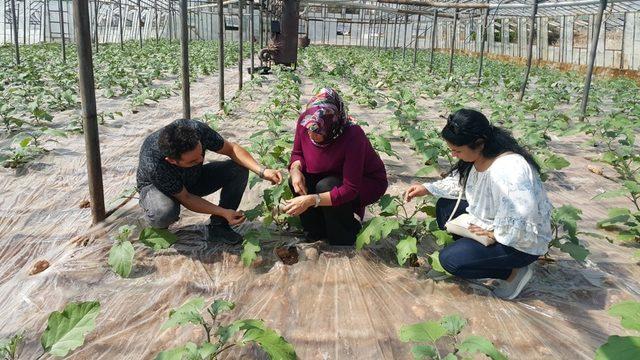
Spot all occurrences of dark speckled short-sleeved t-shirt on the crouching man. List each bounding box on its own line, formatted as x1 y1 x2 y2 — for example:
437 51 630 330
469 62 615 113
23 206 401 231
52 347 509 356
136 119 224 196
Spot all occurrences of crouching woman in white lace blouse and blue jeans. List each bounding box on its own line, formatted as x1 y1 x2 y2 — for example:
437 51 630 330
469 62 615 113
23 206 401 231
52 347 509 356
405 109 552 299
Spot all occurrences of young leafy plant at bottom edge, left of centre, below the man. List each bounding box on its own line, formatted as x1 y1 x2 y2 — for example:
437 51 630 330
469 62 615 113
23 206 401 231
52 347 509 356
156 297 297 360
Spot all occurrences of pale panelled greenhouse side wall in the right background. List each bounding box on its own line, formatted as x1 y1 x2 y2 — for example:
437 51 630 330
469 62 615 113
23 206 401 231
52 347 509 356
304 11 640 70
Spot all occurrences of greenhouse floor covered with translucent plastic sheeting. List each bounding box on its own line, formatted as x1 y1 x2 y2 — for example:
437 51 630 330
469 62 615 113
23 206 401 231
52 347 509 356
0 59 640 360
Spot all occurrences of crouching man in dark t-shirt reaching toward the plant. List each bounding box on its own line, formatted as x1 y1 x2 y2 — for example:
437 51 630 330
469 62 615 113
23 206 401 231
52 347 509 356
137 119 282 244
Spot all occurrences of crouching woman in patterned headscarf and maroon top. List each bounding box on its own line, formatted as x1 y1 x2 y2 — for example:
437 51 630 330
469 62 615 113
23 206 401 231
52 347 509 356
284 88 388 245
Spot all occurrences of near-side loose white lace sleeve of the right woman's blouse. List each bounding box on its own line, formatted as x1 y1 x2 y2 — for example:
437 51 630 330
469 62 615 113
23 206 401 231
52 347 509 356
492 159 551 255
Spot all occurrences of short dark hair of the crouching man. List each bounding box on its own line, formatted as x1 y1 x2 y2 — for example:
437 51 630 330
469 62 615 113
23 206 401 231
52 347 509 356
158 119 200 160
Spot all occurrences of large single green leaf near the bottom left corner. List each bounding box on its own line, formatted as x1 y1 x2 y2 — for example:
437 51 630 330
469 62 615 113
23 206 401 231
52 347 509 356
40 301 100 356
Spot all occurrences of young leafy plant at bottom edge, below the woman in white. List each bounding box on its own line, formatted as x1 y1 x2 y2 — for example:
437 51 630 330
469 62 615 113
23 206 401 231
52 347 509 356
398 315 507 360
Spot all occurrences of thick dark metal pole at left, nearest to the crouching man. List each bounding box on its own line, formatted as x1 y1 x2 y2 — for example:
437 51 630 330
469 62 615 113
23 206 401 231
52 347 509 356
73 0 105 224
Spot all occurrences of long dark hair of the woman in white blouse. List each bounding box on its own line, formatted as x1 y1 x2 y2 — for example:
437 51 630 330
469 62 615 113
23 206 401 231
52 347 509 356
440 109 540 188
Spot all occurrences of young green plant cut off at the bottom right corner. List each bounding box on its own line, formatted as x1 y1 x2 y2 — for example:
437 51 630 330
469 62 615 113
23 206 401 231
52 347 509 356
595 301 640 360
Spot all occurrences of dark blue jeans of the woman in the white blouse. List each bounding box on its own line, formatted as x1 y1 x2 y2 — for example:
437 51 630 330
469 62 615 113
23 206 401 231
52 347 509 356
436 198 538 280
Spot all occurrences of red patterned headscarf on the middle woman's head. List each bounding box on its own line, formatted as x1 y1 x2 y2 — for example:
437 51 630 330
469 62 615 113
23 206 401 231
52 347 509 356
298 88 354 146
